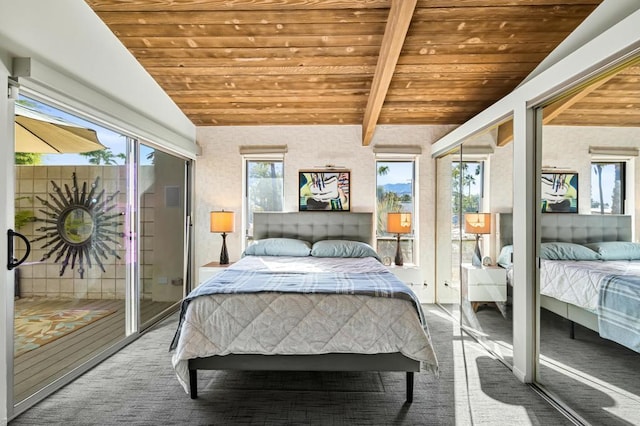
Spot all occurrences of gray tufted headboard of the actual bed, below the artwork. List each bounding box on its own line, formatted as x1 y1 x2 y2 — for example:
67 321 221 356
253 211 374 244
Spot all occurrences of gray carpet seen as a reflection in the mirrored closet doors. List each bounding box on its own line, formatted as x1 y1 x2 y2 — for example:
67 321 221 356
473 307 640 426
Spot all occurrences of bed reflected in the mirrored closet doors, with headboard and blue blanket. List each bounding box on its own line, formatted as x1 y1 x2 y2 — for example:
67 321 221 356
499 213 640 352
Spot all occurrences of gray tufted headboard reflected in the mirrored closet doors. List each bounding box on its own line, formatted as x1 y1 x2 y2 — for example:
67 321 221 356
498 213 632 247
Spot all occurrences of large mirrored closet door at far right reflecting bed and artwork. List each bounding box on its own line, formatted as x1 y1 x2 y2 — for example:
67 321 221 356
536 58 640 425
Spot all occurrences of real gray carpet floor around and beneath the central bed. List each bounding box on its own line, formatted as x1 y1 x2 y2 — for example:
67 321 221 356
9 305 571 426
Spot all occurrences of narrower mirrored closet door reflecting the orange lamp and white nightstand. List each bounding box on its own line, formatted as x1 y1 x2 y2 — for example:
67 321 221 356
453 122 513 365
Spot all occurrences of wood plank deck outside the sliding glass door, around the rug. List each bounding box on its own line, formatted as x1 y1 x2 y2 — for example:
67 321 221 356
13 298 175 403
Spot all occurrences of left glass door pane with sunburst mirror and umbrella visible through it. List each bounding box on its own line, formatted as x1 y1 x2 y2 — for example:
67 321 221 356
13 97 130 404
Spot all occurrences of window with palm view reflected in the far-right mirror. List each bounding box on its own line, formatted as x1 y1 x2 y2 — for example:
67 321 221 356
591 161 625 214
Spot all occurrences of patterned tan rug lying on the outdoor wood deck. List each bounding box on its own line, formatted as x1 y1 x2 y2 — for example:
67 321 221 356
14 309 115 357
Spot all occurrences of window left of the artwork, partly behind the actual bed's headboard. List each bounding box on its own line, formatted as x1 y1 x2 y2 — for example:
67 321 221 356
245 158 284 239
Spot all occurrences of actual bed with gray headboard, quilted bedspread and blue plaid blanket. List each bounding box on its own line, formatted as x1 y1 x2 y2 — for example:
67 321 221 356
171 212 438 402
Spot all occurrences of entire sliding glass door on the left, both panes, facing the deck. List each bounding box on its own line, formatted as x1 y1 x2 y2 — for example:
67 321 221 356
7 96 189 417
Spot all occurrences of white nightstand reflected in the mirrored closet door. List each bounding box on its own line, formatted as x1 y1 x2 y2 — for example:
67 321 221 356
462 263 507 312
